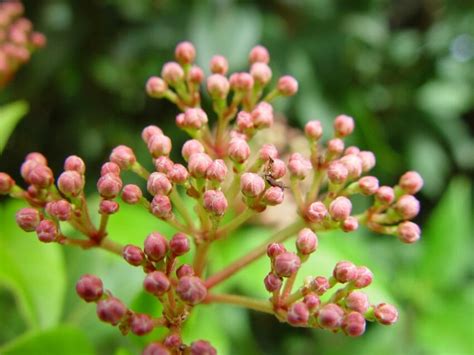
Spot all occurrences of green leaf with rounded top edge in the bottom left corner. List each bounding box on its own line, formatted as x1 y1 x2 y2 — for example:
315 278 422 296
0 325 94 355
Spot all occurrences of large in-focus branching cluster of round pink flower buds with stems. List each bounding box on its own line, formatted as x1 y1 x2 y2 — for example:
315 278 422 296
0 42 423 354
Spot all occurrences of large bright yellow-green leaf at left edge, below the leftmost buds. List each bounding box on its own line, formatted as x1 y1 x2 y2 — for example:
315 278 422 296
0 201 66 328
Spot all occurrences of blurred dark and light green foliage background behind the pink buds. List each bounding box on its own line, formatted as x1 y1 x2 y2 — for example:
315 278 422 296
0 0 474 355
